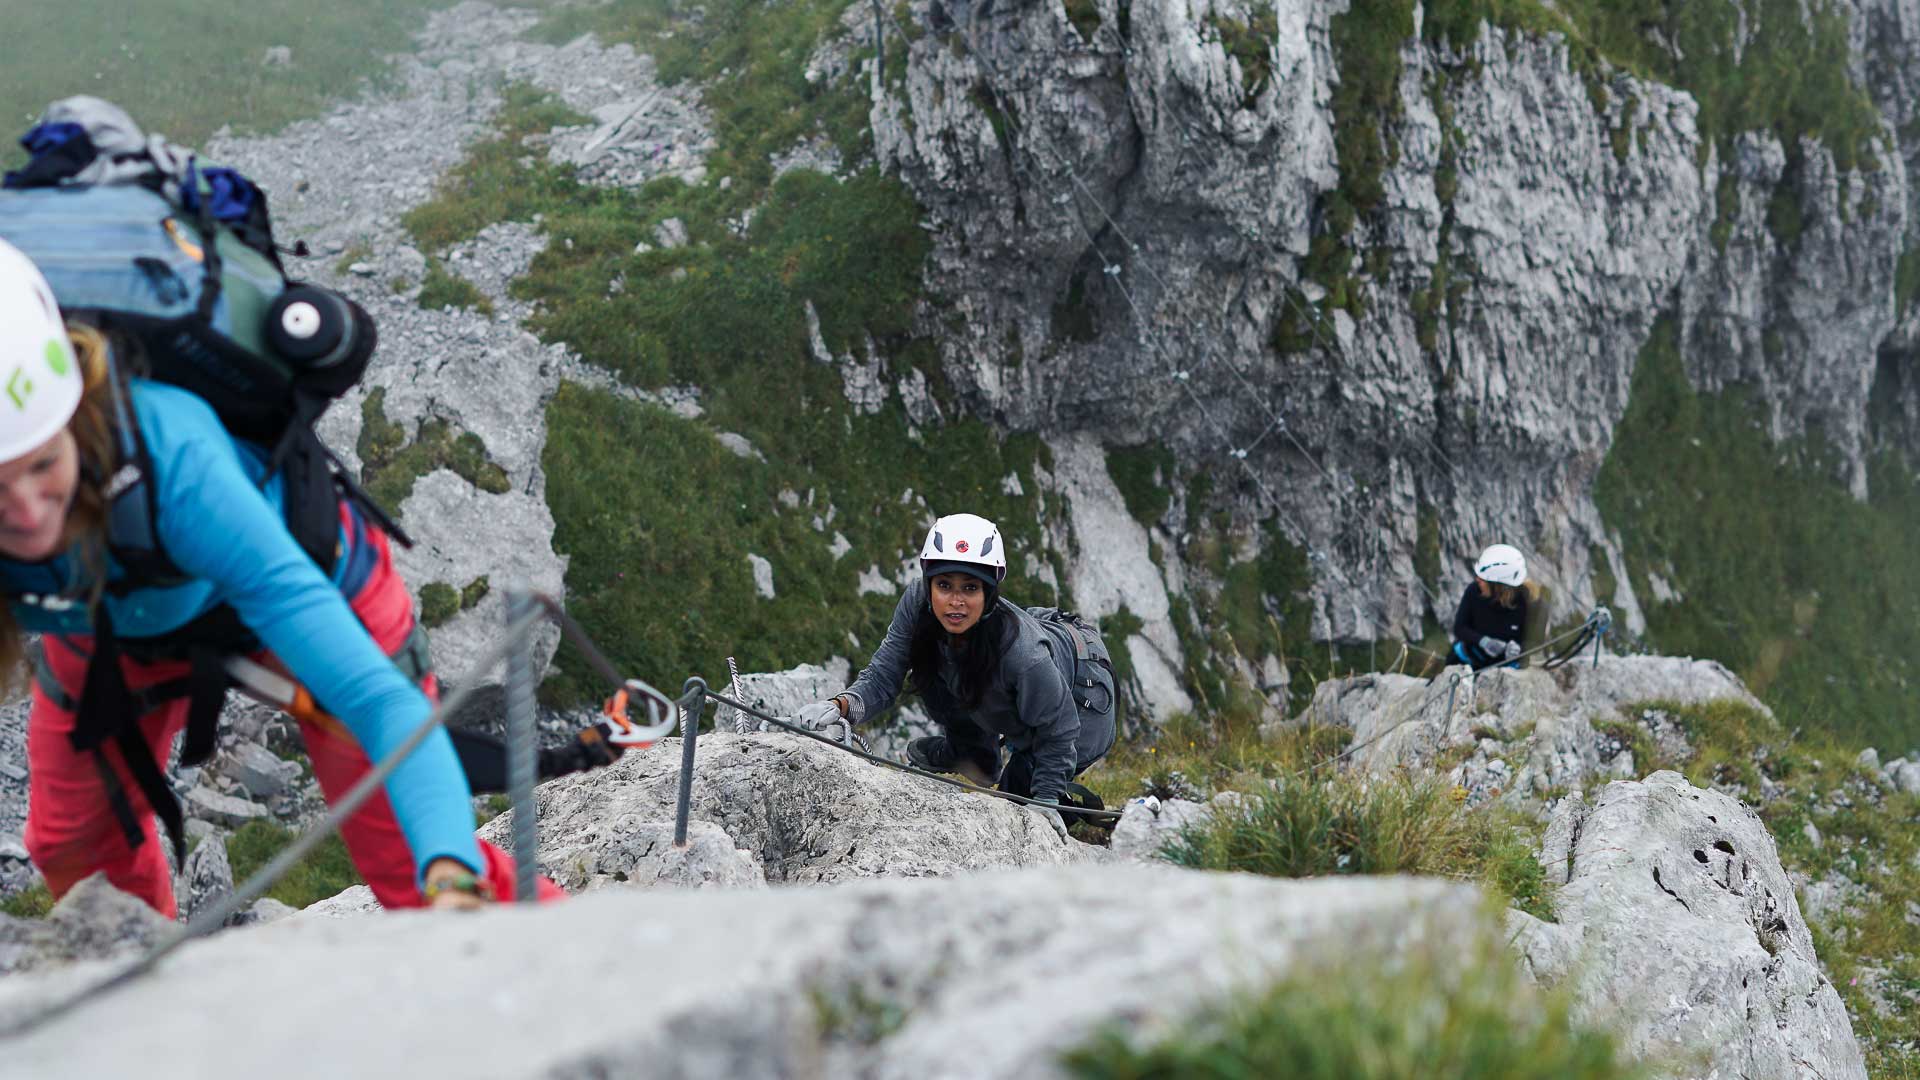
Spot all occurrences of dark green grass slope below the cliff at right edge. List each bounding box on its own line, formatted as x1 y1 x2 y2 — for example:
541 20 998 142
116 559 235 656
1596 319 1920 748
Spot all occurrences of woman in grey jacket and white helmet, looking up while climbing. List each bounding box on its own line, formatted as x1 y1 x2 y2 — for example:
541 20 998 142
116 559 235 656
799 513 1119 836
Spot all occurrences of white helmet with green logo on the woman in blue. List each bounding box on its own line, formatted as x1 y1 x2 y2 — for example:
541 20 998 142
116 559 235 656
0 240 83 461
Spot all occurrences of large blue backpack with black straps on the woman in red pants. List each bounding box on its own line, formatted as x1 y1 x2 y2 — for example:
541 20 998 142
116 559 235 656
0 98 411 857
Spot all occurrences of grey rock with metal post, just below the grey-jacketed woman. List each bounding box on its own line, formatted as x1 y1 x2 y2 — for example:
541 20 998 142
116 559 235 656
480 732 1106 884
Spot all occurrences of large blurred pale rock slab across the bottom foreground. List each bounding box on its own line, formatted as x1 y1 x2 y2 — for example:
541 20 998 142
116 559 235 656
0 867 1480 1080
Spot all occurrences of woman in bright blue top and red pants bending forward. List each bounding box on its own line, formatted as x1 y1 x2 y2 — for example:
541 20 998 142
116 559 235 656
0 244 559 917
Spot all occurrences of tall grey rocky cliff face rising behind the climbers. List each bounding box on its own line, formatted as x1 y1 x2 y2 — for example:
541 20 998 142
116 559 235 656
864 0 1920 714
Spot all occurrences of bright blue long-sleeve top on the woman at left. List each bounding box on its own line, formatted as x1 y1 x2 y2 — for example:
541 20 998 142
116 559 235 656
0 379 486 872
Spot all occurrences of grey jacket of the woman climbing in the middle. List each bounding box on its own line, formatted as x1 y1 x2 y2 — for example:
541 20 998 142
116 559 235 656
843 580 1112 801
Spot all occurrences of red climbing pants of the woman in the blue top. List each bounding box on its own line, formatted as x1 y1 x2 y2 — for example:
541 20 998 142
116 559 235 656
25 528 561 919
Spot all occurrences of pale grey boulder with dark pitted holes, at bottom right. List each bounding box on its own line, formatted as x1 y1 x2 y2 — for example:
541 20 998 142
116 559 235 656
1517 773 1866 1080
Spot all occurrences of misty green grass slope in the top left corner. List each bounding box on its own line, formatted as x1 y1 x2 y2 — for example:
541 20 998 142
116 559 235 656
0 0 453 148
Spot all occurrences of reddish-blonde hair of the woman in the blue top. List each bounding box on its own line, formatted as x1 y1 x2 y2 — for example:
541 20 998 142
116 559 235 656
0 323 115 690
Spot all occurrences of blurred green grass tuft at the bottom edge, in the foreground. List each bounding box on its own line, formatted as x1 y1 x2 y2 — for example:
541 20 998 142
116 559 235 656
1064 924 1647 1080
